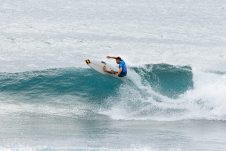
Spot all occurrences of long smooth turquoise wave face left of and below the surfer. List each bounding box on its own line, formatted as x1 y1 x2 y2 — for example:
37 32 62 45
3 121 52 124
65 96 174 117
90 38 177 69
0 69 120 100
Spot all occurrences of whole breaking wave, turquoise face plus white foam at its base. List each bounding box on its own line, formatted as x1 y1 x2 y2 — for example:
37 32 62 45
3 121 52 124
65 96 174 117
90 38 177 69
0 64 225 121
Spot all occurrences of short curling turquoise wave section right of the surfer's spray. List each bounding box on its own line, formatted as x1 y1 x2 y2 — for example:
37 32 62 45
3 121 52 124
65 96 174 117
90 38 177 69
133 64 193 97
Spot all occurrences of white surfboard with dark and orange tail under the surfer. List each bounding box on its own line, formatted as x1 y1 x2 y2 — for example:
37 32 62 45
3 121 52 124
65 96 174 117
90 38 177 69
85 59 119 78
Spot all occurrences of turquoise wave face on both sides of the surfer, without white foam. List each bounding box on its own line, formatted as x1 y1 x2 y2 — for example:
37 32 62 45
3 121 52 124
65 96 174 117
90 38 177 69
0 64 193 100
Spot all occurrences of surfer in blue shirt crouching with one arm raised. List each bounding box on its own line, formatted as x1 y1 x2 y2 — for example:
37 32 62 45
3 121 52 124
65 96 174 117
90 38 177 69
103 56 127 77
